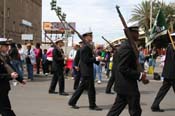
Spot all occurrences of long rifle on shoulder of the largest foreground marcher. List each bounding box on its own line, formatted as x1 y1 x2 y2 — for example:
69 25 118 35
116 5 149 84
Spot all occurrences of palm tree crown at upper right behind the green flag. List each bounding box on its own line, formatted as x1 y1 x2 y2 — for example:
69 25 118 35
129 0 175 35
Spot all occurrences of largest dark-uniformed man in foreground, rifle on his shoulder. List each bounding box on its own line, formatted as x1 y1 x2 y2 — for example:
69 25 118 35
107 26 146 116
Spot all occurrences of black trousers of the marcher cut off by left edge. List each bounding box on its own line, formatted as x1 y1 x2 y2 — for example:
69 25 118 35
0 90 16 116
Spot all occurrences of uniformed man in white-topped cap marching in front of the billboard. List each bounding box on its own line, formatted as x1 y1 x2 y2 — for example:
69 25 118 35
49 39 68 96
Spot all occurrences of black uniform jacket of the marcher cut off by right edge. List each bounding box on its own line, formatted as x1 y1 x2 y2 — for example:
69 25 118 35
162 44 175 79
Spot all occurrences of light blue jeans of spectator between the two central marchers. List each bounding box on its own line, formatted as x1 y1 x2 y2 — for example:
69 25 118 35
94 64 102 81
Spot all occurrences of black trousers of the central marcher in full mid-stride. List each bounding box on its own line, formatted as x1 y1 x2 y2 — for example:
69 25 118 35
69 77 96 107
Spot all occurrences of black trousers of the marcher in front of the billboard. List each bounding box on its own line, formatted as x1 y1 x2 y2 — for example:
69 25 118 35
49 71 64 93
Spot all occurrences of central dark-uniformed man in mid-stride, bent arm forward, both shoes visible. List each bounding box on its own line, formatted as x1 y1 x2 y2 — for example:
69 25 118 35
68 32 102 110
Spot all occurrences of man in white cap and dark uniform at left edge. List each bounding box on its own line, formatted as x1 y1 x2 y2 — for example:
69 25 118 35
0 38 26 116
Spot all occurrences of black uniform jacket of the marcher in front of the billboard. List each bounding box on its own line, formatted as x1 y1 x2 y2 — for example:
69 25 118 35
52 47 64 73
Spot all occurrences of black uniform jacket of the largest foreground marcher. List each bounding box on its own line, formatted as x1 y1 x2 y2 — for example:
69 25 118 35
112 40 140 95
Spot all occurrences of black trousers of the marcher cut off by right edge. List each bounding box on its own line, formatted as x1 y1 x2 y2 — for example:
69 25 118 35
151 79 175 108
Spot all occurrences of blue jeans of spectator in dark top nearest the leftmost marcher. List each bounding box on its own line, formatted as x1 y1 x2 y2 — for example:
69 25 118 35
10 60 23 78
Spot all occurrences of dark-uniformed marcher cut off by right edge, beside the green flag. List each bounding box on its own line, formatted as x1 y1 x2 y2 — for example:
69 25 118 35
151 35 175 112
